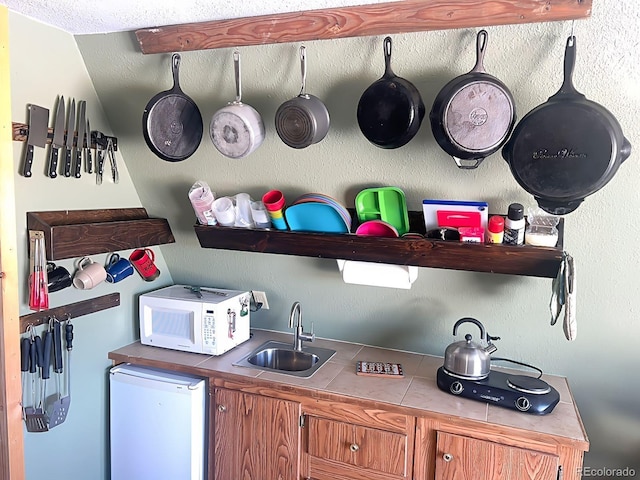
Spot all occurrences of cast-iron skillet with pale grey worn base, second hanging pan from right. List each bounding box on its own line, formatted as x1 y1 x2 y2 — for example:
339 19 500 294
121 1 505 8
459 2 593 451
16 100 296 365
429 30 516 169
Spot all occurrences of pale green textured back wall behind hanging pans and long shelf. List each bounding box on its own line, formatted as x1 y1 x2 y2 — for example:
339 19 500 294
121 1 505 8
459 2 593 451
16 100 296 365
72 0 640 471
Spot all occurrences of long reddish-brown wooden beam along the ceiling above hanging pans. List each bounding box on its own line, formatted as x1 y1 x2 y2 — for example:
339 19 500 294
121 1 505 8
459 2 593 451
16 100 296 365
136 0 592 54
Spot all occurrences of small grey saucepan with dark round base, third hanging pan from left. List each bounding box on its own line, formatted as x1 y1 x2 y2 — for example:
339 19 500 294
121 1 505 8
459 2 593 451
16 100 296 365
276 46 329 148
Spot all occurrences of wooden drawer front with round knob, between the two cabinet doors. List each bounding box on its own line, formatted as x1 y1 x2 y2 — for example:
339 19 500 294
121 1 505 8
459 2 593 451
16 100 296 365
307 416 410 478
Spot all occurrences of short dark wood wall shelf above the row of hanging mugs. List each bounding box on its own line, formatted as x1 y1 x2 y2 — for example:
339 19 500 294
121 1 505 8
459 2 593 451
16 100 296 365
27 208 175 261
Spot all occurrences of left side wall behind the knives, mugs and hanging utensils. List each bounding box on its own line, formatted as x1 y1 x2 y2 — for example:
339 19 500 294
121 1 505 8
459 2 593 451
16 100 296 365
9 13 172 480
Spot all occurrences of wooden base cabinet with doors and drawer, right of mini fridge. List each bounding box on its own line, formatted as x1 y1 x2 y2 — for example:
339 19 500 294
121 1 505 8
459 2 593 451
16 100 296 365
109 344 589 480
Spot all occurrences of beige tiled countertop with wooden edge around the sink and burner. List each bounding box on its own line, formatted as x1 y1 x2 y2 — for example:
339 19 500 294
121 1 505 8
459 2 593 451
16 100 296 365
109 329 588 445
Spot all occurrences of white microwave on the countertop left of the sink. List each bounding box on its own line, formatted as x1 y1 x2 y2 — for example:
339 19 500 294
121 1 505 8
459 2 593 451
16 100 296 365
139 285 251 355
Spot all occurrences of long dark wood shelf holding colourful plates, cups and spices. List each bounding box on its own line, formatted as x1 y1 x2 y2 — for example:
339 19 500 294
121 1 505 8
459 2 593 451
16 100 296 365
194 212 564 278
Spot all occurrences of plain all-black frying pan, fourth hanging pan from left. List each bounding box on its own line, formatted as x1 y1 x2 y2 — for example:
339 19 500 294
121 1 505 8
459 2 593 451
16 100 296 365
358 37 425 148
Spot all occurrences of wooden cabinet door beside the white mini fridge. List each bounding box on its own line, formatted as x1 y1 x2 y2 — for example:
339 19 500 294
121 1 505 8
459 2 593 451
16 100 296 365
211 388 300 480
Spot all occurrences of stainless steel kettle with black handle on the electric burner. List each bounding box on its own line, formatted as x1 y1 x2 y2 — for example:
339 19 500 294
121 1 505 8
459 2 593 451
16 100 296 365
444 317 500 380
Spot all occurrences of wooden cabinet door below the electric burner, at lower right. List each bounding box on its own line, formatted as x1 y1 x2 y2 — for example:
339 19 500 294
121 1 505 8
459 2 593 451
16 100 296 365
436 432 558 480
